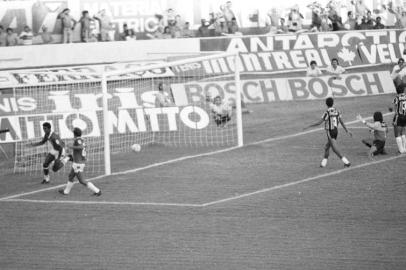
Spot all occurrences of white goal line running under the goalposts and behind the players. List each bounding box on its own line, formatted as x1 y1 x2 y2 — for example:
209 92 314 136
0 113 392 205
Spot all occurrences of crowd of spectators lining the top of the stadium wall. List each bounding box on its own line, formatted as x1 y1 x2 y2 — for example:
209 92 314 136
0 0 406 46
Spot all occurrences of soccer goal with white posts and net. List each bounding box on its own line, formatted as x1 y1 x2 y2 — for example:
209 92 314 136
2 53 243 175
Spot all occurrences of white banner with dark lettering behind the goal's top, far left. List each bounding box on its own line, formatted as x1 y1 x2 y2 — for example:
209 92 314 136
0 61 174 89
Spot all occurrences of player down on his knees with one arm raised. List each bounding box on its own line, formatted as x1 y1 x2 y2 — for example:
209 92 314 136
357 112 388 158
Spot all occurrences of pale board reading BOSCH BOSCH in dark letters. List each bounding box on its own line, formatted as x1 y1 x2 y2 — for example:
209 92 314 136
171 72 395 106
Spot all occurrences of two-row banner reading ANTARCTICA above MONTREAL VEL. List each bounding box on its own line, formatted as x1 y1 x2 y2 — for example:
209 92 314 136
200 30 406 74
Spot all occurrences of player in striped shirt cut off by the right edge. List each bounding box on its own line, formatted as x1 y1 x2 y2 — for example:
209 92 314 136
393 87 406 154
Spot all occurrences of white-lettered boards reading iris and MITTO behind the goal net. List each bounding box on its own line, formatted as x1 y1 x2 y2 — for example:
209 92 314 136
0 87 210 143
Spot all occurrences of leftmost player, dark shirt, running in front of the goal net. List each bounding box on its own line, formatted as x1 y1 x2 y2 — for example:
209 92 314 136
28 122 68 184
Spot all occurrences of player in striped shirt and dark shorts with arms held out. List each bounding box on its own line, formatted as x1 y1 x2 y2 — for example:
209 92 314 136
304 97 352 167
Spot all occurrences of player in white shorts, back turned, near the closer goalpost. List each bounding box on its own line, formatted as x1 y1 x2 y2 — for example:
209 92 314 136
59 128 101 196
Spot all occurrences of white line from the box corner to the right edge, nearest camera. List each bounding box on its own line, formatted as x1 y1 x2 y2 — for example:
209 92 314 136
202 155 405 207
